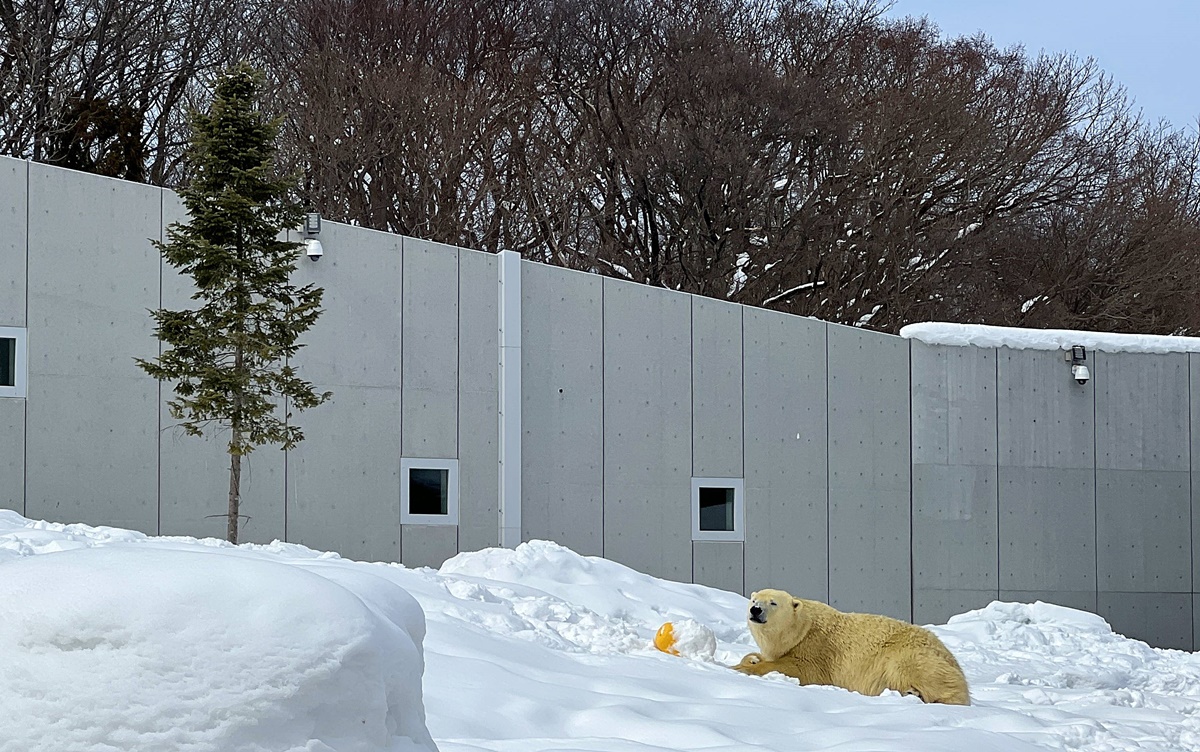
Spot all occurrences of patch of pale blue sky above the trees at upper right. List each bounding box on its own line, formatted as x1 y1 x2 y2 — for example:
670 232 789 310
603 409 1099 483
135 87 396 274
888 0 1200 132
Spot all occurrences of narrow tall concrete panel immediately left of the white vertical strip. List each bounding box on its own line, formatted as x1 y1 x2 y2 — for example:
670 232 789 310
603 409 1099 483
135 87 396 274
458 251 500 551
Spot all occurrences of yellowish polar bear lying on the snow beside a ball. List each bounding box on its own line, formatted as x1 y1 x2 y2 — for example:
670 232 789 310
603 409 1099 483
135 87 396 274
733 590 971 705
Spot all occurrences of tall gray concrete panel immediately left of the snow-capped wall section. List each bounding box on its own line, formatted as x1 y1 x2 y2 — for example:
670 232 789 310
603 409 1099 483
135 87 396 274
828 324 912 619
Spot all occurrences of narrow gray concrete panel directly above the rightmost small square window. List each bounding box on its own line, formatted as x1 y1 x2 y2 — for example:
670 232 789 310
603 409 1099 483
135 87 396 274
691 296 743 477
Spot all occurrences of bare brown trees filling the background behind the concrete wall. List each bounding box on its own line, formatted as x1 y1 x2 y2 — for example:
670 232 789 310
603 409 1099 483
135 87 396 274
0 0 1200 333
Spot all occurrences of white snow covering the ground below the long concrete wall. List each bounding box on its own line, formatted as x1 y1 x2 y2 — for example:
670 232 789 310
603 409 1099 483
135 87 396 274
0 511 1200 752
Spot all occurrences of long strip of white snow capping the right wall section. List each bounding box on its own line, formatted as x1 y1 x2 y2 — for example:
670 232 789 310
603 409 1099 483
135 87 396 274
900 321 1200 353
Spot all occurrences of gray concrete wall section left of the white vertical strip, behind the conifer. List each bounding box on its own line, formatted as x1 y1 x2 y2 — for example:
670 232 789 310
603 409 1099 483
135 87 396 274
0 160 498 565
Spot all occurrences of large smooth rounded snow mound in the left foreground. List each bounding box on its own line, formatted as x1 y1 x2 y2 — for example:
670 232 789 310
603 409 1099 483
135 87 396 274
0 537 436 752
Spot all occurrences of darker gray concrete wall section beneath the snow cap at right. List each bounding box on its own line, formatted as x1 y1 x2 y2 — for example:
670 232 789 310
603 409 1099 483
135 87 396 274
912 342 1200 650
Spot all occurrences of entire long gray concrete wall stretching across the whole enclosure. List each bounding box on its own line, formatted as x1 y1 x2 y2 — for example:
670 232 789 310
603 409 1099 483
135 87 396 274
0 158 1200 649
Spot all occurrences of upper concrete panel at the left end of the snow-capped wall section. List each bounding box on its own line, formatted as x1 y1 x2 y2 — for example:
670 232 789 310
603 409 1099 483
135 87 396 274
912 339 996 467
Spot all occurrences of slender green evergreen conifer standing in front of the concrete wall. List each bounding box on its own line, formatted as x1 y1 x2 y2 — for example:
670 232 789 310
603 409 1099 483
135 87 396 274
138 64 331 543
